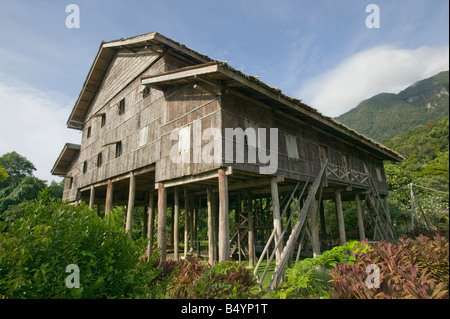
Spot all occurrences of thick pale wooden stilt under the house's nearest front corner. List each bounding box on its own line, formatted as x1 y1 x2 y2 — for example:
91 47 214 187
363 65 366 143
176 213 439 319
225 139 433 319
219 168 230 261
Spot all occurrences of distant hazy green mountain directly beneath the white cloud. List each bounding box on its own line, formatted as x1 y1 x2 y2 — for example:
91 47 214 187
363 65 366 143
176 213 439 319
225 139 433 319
336 71 449 142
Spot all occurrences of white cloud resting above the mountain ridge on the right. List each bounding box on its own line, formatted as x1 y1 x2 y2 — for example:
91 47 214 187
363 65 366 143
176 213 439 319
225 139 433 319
296 46 449 117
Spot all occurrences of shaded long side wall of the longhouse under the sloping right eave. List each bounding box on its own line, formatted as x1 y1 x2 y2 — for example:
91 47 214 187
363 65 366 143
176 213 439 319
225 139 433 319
222 94 387 195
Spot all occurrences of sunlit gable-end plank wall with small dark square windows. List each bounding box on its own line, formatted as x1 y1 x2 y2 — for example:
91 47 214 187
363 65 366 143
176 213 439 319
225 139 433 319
63 51 166 200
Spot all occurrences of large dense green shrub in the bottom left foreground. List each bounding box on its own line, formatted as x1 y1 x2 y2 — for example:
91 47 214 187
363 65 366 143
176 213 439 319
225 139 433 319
0 192 160 298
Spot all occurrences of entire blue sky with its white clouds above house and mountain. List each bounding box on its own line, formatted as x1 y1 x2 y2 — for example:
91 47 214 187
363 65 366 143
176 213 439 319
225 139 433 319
0 0 449 184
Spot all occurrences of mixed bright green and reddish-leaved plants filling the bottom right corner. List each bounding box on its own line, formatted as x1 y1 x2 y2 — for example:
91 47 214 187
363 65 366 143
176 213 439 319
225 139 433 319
276 234 449 299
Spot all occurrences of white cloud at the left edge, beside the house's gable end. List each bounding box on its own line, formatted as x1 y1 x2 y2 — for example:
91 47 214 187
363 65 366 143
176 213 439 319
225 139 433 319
0 74 81 182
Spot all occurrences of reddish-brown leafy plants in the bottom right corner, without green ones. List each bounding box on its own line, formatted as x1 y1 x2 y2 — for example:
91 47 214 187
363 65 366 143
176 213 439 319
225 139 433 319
329 235 449 299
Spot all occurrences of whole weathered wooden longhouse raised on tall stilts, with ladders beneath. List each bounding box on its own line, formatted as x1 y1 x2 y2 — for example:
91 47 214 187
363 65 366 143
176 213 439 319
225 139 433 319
52 33 402 287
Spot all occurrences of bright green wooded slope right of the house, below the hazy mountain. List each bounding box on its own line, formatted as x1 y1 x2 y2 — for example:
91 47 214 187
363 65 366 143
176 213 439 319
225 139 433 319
383 116 449 232
